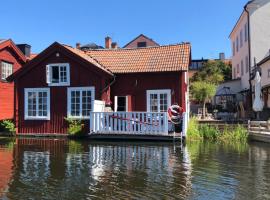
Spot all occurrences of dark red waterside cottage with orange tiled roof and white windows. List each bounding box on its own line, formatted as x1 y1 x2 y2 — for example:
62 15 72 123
9 40 191 134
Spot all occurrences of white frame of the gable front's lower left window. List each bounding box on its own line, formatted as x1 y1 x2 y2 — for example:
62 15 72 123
24 88 51 120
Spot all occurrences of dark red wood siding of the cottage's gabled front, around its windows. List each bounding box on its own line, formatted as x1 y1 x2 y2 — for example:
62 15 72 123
16 51 109 134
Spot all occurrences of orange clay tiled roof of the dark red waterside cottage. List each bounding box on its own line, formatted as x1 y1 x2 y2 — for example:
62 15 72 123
85 43 191 73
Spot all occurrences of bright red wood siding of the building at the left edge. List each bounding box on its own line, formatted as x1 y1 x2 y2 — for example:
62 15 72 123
0 47 22 120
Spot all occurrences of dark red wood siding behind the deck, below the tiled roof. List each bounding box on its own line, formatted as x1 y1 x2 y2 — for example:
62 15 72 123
111 72 186 111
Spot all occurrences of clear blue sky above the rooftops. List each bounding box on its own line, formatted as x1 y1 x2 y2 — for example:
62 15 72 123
0 0 247 59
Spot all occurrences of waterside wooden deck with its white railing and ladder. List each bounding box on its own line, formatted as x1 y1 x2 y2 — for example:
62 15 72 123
88 112 187 141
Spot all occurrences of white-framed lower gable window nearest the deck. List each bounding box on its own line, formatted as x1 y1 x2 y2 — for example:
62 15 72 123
67 87 95 119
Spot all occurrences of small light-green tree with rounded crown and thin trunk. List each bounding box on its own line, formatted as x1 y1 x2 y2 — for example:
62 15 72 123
191 81 217 119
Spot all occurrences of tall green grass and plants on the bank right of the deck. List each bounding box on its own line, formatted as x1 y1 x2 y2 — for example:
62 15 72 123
187 118 248 143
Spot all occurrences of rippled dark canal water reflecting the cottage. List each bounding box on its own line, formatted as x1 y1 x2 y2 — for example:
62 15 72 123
0 138 270 200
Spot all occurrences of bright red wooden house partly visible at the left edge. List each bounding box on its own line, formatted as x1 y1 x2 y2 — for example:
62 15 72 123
0 40 26 120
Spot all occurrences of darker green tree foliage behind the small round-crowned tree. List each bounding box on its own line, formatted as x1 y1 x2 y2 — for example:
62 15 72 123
191 61 232 85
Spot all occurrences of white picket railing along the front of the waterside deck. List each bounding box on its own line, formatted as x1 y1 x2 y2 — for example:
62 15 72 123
90 112 168 135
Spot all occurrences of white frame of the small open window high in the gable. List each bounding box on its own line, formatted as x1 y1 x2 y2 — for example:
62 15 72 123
46 63 70 86
